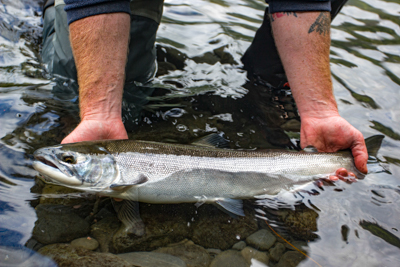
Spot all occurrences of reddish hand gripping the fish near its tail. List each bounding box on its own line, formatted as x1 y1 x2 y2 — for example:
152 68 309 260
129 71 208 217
300 115 368 173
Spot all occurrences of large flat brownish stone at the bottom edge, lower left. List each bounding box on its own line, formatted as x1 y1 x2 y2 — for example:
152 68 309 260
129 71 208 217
38 244 132 267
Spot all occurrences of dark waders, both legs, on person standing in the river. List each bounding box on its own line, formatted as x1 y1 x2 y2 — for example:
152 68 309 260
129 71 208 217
42 0 347 101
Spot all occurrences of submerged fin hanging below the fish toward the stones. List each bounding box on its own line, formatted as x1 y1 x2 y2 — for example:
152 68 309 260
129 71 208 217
112 199 145 238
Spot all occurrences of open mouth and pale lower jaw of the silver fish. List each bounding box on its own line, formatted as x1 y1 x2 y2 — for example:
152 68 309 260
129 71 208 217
32 153 82 186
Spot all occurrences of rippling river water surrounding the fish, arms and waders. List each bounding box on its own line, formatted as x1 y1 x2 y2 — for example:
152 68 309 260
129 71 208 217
0 0 400 266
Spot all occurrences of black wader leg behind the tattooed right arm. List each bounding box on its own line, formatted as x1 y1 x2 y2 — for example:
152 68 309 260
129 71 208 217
242 0 347 87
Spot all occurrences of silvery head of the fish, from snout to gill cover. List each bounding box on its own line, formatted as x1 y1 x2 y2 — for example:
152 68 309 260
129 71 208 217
32 142 119 191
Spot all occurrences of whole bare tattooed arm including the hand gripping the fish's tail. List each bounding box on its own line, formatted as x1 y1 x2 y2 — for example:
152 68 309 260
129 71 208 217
271 11 368 173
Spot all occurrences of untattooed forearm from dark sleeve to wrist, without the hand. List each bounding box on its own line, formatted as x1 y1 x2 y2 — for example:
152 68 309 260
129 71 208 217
70 13 130 120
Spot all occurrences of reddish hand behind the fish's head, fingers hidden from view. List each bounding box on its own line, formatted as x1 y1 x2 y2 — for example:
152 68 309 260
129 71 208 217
61 119 128 144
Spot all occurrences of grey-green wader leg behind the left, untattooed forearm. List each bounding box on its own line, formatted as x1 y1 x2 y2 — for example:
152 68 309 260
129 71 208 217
42 0 163 123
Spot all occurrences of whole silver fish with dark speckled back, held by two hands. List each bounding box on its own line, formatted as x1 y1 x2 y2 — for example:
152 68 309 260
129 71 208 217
33 134 383 236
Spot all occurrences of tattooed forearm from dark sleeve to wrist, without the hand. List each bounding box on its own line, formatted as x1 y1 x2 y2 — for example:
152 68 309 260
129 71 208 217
271 12 338 118
